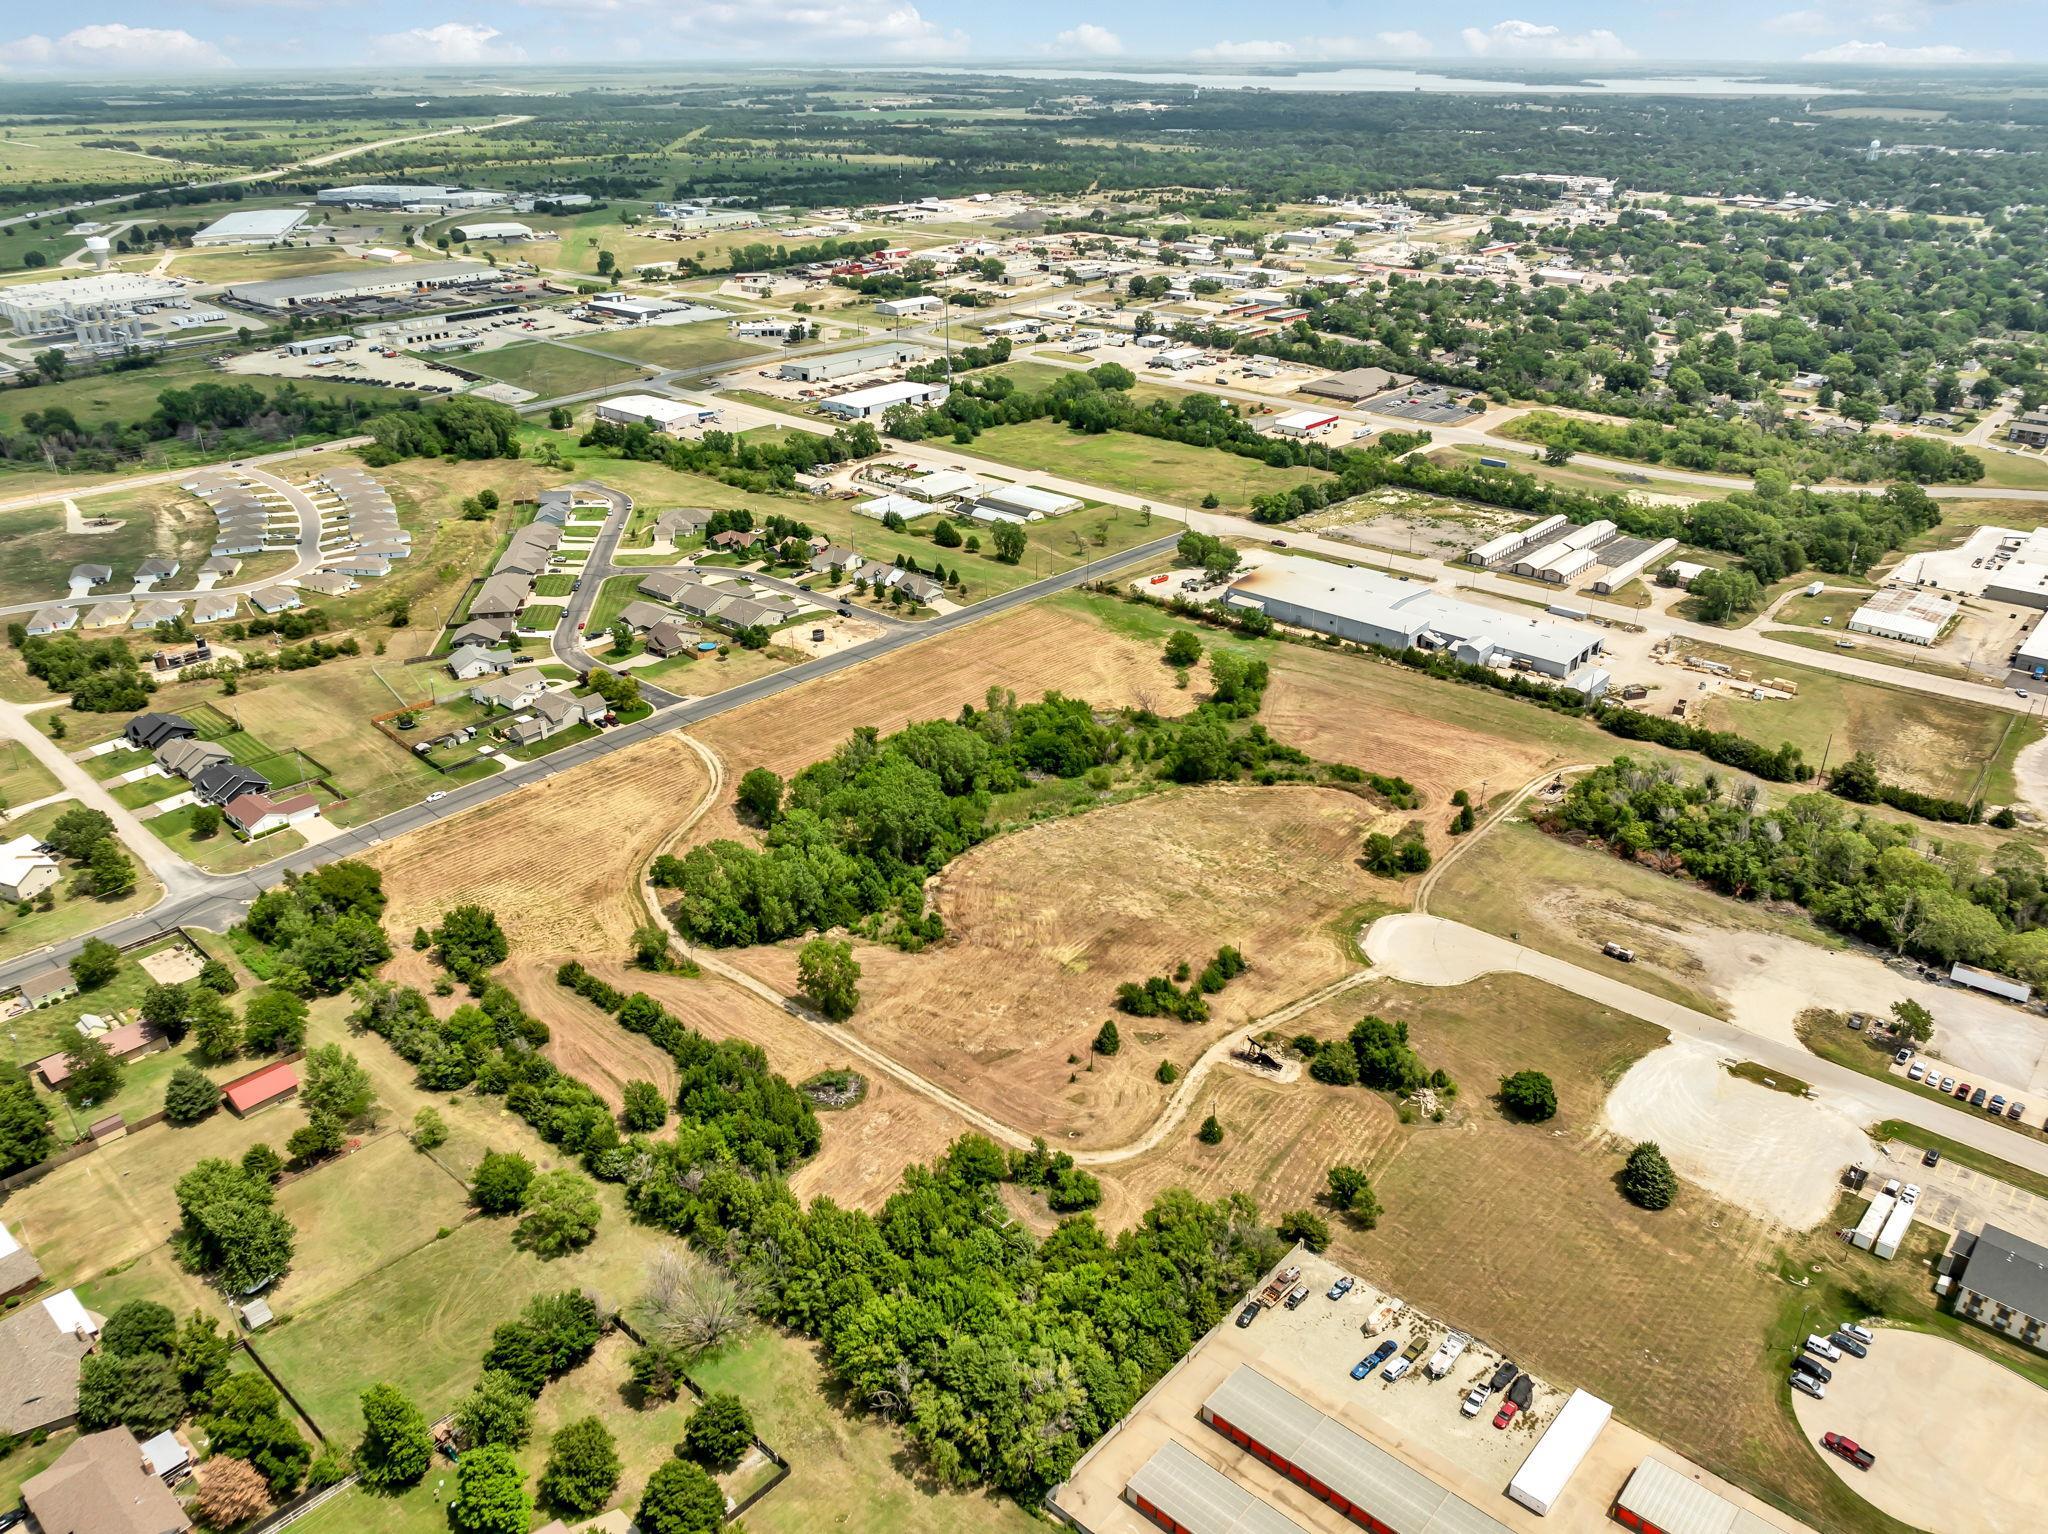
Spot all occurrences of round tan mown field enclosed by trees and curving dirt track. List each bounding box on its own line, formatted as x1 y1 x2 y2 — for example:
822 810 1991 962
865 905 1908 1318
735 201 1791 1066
733 786 1399 1145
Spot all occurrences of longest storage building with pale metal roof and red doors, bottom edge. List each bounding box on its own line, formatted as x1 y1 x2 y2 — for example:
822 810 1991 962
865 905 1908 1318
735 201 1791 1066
1202 1364 1509 1534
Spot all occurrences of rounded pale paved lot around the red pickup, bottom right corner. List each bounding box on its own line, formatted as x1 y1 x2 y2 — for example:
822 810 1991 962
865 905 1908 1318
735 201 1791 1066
1792 1329 2048 1534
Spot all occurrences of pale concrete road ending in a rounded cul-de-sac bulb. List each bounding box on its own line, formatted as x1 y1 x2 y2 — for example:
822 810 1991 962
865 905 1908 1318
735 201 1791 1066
1364 911 2048 1174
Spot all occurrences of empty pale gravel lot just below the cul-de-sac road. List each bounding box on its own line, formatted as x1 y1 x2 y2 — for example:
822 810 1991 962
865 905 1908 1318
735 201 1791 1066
1606 1040 1876 1231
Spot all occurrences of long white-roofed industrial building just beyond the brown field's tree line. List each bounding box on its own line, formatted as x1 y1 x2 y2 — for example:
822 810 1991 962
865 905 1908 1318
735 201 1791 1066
1225 557 1602 680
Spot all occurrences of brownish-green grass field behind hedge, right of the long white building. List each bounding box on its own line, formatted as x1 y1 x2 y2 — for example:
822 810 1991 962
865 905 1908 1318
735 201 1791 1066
1694 645 2036 805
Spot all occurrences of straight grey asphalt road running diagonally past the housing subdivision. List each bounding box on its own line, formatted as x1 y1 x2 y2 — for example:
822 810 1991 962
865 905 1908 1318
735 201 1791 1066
0 537 1174 989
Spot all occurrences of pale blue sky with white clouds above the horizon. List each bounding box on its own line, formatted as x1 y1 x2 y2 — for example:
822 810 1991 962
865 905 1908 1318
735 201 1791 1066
0 0 2023 78
